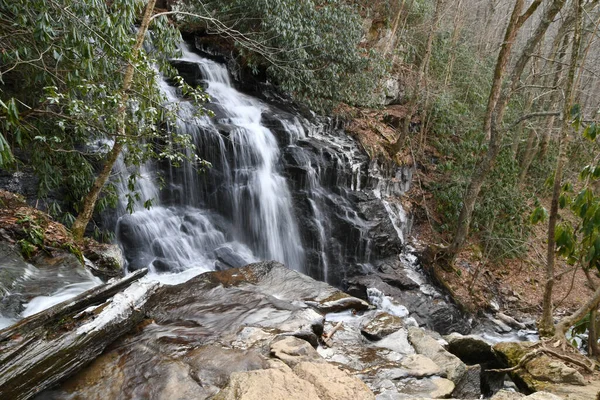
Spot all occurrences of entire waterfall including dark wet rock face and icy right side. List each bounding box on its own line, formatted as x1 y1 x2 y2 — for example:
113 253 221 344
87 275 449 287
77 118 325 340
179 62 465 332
117 45 406 285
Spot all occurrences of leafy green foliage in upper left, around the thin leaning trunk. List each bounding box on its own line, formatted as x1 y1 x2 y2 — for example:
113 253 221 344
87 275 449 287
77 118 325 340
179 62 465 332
0 0 204 222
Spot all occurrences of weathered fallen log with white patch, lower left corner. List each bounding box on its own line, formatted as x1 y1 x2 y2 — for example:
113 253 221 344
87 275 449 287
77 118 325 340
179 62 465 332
0 270 159 400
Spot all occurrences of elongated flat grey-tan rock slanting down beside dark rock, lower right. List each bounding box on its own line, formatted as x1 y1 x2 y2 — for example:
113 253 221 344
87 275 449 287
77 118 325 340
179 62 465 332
408 327 467 383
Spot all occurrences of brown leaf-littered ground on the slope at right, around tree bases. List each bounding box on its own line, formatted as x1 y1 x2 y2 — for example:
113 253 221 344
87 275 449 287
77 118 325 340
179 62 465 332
407 168 600 319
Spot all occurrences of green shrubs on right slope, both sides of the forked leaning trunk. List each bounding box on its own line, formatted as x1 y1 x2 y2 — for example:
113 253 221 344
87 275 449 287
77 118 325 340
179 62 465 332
426 22 542 259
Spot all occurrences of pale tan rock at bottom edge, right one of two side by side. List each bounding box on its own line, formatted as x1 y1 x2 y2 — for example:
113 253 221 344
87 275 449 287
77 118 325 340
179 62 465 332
292 362 375 400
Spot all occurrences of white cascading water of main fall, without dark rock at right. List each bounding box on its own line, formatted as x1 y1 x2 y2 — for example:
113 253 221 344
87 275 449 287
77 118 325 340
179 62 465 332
117 44 304 282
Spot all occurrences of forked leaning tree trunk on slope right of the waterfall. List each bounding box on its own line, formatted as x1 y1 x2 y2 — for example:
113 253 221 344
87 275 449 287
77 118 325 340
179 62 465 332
443 0 566 263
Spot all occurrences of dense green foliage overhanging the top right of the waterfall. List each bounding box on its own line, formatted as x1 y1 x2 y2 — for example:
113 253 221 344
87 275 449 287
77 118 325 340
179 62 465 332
182 0 386 110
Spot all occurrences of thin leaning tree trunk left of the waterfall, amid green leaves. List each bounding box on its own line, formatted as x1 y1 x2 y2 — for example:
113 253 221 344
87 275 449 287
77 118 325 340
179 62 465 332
71 0 156 241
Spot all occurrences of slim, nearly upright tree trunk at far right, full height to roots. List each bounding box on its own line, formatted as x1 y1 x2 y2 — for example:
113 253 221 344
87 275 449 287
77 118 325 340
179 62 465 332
538 0 580 336
